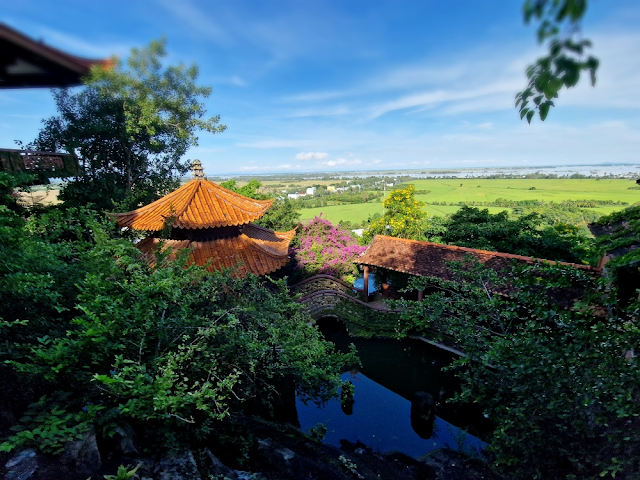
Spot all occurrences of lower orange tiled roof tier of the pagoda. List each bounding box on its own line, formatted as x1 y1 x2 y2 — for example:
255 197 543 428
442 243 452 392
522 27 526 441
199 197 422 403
136 223 296 277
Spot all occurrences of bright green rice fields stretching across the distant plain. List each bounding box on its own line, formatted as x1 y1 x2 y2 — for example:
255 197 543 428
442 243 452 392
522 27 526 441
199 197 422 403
300 178 640 223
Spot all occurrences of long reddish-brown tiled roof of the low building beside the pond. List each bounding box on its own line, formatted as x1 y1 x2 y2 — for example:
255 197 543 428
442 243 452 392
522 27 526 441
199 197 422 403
355 235 600 280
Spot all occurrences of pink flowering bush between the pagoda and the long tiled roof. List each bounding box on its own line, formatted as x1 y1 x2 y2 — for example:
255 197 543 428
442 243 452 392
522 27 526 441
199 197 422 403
292 217 367 283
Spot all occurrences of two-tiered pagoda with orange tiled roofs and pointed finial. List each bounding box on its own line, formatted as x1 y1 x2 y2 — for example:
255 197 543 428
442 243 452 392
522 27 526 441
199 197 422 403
115 160 296 277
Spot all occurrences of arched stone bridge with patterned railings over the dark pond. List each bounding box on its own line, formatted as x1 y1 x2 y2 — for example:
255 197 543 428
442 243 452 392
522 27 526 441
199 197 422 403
289 275 399 320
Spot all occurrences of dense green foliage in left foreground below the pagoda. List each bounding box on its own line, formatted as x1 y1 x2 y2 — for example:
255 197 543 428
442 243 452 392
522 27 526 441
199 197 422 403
0 203 353 453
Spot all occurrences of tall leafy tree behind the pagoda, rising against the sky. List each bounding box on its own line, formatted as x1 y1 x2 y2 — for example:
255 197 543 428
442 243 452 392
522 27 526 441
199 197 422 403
32 40 226 210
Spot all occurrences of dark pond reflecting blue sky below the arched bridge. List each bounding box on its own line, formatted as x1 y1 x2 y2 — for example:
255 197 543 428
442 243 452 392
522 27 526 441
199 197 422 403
296 321 490 458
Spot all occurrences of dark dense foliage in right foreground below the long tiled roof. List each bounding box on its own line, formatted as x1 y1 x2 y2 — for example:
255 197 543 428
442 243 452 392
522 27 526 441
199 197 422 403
398 260 640 479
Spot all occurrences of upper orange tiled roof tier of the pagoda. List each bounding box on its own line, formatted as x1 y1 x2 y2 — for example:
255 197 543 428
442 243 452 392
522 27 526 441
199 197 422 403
115 178 273 231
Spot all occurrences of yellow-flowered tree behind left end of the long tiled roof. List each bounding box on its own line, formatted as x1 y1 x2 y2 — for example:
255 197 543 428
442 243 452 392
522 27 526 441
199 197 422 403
362 185 427 243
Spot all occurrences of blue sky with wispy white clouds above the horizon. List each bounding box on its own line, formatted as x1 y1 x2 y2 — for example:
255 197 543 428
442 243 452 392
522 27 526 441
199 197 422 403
0 0 640 175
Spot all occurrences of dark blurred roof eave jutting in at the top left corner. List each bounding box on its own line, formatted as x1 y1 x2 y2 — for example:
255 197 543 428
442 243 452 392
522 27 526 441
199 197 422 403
0 23 112 88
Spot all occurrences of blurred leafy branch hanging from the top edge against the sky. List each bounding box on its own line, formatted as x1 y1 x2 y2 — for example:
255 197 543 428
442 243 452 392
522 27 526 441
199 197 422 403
516 0 599 123
